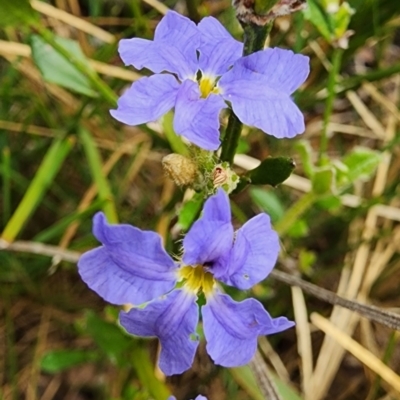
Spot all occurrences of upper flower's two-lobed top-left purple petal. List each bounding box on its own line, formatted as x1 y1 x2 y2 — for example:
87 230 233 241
119 11 200 79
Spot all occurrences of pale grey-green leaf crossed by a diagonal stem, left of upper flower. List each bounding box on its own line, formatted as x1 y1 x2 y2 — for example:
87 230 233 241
30 35 97 97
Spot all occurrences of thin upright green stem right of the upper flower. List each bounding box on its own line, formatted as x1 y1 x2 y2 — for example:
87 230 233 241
319 48 343 164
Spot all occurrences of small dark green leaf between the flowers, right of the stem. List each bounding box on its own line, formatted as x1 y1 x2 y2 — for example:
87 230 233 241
245 157 296 186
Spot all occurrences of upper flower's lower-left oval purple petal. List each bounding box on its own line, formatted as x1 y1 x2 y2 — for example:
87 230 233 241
110 74 180 125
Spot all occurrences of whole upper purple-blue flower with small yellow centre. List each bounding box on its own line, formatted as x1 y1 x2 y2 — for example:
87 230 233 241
111 11 309 150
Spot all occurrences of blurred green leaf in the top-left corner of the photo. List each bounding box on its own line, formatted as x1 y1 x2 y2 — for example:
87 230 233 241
0 0 39 27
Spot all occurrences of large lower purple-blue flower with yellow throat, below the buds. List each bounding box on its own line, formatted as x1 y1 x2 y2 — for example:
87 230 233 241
78 189 294 375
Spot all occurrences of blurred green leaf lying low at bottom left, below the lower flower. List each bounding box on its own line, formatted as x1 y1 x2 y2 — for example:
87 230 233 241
40 350 99 374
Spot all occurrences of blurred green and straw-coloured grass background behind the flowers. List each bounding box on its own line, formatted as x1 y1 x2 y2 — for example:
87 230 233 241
0 0 400 400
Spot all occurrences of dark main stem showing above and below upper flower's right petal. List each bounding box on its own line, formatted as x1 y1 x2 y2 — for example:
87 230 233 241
221 22 272 164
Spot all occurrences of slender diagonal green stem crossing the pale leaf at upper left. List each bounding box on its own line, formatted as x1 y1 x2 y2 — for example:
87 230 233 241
35 25 117 107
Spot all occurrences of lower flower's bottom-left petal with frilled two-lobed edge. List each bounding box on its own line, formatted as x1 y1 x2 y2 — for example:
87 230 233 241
120 290 199 375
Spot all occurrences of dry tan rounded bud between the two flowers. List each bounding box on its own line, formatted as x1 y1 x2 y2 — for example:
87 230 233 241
162 153 198 186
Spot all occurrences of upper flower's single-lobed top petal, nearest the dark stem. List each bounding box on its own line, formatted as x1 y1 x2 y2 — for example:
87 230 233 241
198 17 243 76
